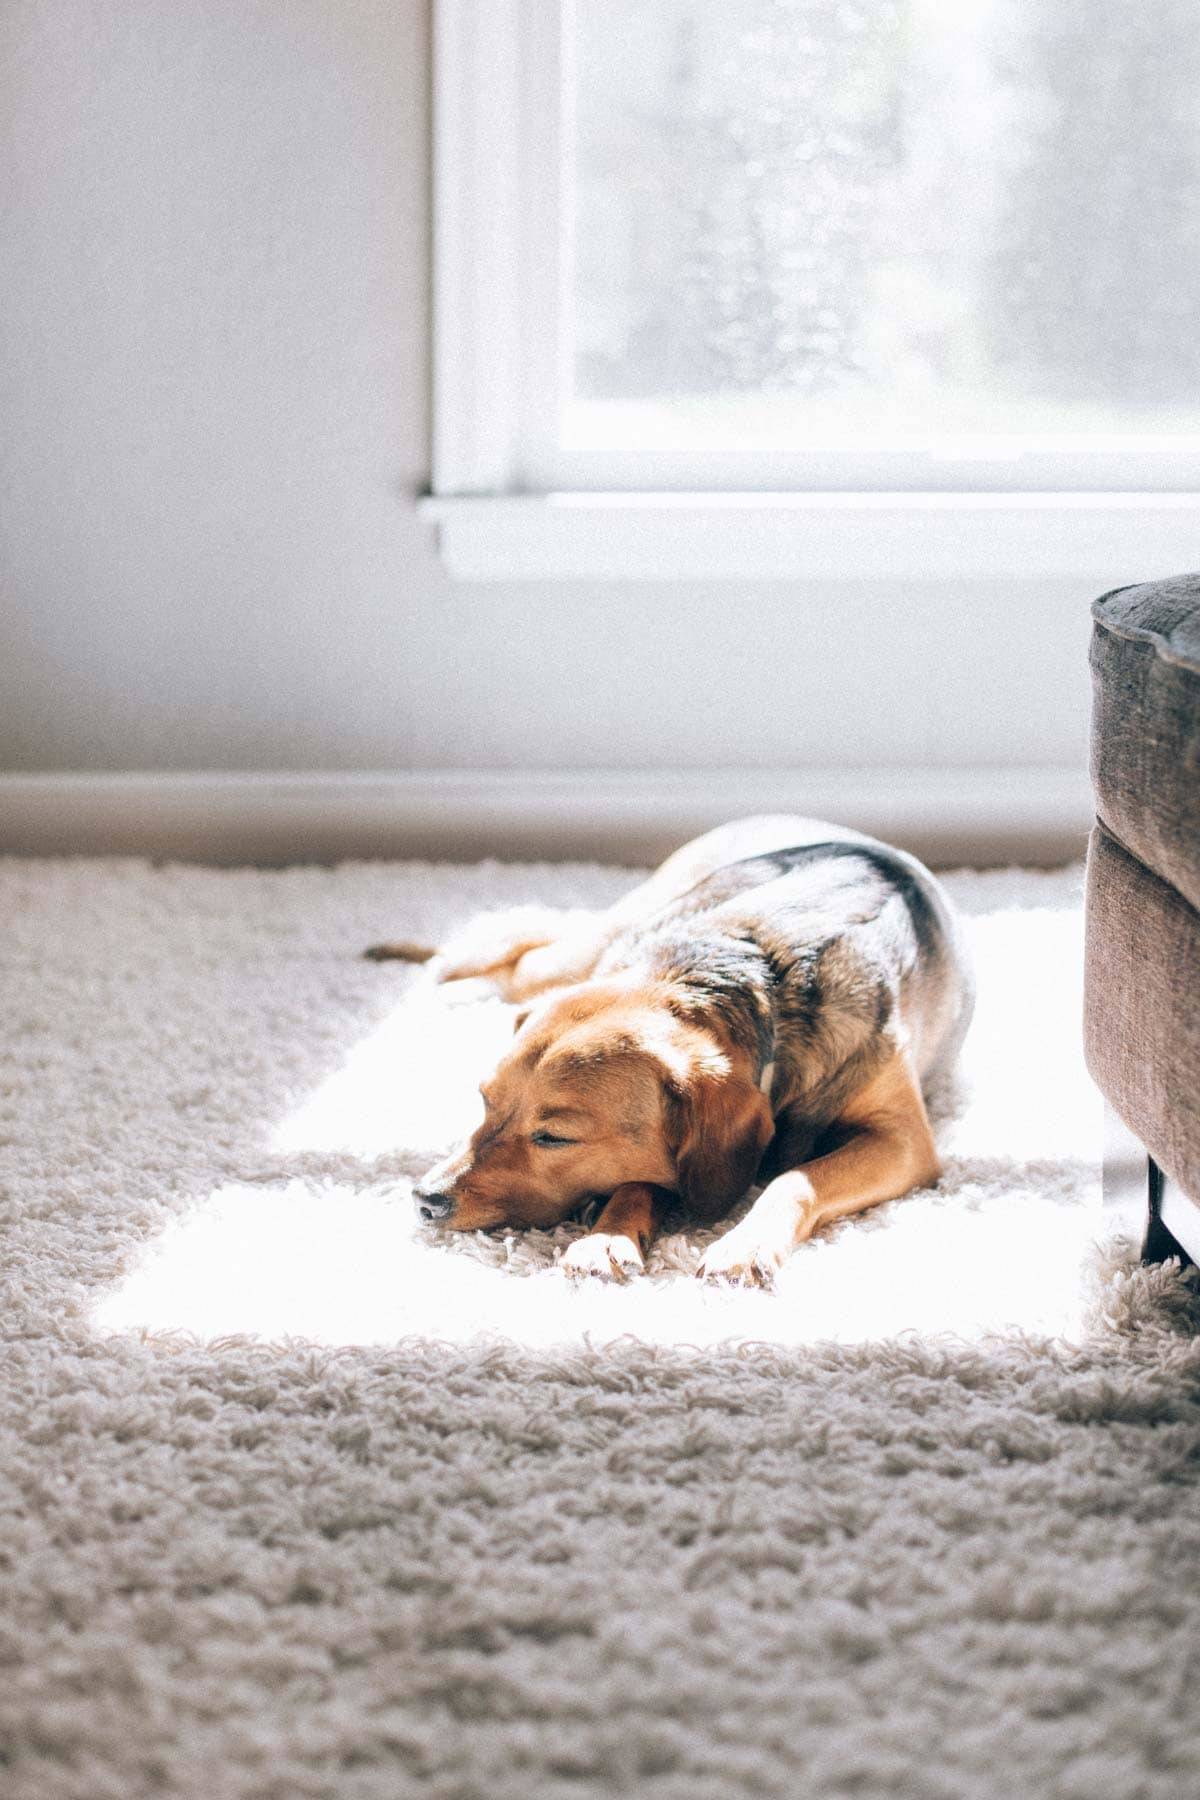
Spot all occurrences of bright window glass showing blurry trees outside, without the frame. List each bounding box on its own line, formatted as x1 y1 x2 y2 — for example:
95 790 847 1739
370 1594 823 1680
569 0 1200 448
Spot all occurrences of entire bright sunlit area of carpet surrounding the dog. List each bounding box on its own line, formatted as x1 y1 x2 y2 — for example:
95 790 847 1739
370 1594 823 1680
95 877 1112 1345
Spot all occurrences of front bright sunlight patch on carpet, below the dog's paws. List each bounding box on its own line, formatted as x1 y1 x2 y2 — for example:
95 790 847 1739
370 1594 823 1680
95 1165 1097 1346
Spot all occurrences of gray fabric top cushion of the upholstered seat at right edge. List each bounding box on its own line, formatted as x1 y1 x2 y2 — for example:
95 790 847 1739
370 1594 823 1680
1092 574 1200 907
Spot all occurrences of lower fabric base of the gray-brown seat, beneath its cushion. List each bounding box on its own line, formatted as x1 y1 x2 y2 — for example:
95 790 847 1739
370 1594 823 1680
1083 826 1200 1199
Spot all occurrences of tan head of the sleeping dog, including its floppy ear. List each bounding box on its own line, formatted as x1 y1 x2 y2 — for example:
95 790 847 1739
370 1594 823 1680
416 981 774 1231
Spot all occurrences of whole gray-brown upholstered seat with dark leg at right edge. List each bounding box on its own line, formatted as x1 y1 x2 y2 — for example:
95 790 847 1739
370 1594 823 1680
1083 574 1200 1262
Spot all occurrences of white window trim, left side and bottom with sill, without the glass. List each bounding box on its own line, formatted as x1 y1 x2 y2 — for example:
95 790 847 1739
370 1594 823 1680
421 0 1200 585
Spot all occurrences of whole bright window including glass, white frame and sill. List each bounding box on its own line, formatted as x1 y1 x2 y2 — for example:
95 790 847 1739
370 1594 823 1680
424 0 1200 580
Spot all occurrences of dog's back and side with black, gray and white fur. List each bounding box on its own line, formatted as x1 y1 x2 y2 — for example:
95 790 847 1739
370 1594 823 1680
596 817 973 1116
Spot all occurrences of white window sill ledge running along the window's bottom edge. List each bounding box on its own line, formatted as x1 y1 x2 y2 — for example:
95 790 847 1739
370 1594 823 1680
419 493 1200 587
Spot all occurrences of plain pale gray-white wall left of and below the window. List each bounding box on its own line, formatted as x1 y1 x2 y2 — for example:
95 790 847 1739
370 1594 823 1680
0 0 1101 795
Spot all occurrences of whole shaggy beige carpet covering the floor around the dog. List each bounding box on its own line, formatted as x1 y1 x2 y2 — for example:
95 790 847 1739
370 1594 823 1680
0 860 1200 1800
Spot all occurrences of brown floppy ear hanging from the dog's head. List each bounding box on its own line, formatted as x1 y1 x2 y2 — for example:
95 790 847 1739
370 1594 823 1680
667 1073 775 1219
